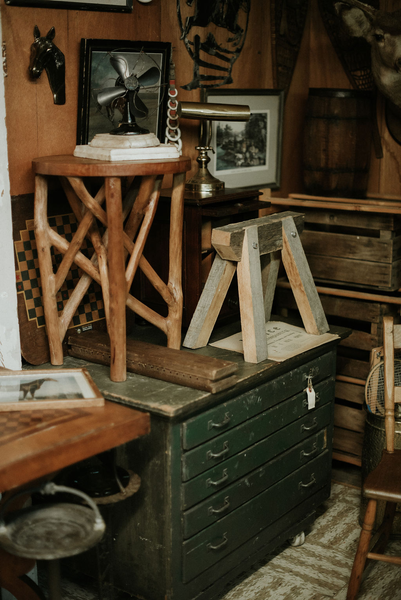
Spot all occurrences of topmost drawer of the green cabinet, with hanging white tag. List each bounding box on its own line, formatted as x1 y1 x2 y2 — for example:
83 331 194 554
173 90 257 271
182 351 335 450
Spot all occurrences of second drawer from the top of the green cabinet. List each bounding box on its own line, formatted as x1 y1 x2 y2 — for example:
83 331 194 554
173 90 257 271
182 378 334 481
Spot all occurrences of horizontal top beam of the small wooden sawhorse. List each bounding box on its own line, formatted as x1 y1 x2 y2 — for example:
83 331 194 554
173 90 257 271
212 211 303 261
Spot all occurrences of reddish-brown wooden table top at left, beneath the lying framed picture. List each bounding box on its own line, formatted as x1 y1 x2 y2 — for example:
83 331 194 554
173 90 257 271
0 401 150 492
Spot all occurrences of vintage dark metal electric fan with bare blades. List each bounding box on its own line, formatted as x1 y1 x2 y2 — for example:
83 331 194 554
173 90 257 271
96 52 160 135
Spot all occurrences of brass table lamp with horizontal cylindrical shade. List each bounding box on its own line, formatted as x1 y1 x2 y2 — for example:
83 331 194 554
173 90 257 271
177 102 251 194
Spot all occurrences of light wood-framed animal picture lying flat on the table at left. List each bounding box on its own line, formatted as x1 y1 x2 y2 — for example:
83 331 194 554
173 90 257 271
0 368 105 412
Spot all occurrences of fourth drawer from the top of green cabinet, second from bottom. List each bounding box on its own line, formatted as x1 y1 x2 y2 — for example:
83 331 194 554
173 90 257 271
183 429 327 539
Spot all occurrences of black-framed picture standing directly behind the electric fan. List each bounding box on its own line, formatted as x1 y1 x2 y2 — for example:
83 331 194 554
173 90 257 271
77 38 171 145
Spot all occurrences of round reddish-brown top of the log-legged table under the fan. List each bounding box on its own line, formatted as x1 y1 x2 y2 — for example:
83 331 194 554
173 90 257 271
32 154 191 177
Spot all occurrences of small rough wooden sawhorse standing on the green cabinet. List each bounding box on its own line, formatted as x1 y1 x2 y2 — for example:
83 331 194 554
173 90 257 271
183 211 329 363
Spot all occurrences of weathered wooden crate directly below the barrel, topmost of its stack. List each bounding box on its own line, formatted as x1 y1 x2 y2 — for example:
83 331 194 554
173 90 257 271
301 208 401 291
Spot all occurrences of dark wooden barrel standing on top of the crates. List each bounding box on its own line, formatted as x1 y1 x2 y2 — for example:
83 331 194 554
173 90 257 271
303 88 373 198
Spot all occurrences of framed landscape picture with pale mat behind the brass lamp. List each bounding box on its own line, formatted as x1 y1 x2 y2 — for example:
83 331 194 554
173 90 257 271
202 88 284 189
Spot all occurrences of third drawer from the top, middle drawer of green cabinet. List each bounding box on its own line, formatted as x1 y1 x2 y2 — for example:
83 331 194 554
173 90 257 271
182 404 332 510
